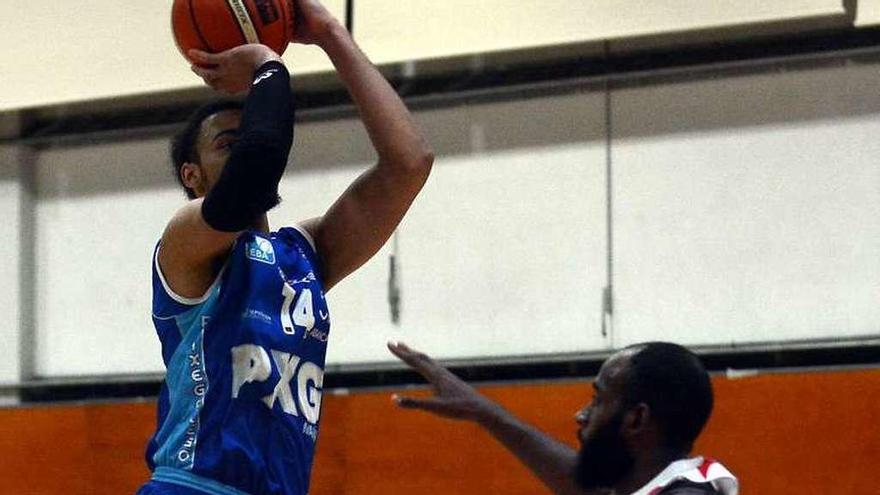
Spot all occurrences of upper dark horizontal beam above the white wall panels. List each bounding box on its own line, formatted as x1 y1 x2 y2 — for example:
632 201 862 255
8 28 880 147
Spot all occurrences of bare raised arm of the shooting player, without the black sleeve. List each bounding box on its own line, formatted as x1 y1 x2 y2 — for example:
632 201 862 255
295 0 434 289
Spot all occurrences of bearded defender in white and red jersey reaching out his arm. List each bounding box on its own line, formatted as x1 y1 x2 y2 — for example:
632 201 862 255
388 342 739 495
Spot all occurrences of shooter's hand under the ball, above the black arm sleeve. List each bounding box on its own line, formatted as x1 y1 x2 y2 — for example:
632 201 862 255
188 44 281 95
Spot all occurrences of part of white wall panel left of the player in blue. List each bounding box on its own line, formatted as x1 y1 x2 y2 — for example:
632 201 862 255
36 139 177 376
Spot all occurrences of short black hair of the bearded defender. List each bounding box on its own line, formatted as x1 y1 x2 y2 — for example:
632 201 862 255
624 342 714 453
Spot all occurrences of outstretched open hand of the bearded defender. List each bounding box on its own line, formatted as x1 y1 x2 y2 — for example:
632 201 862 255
388 342 500 423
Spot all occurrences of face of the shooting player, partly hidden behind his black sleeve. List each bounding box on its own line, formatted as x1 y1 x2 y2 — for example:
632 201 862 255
194 110 241 196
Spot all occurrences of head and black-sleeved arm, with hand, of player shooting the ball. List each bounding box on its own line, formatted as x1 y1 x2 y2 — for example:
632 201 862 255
158 45 293 297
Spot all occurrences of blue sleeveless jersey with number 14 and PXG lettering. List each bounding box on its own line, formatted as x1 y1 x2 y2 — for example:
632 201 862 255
147 228 330 495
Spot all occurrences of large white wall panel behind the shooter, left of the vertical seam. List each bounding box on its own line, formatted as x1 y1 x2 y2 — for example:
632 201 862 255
25 88 607 377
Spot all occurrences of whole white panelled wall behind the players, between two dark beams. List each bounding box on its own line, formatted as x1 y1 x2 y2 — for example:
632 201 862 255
0 56 880 379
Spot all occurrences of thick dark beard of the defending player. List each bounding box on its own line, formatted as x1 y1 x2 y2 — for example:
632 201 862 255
574 411 635 490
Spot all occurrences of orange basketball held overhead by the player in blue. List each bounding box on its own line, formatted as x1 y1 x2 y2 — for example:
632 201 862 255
171 0 293 62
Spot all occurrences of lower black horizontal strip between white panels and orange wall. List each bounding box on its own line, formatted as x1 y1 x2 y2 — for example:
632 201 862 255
0 338 880 404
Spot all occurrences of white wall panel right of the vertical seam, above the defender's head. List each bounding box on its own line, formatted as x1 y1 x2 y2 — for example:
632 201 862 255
613 66 880 345
